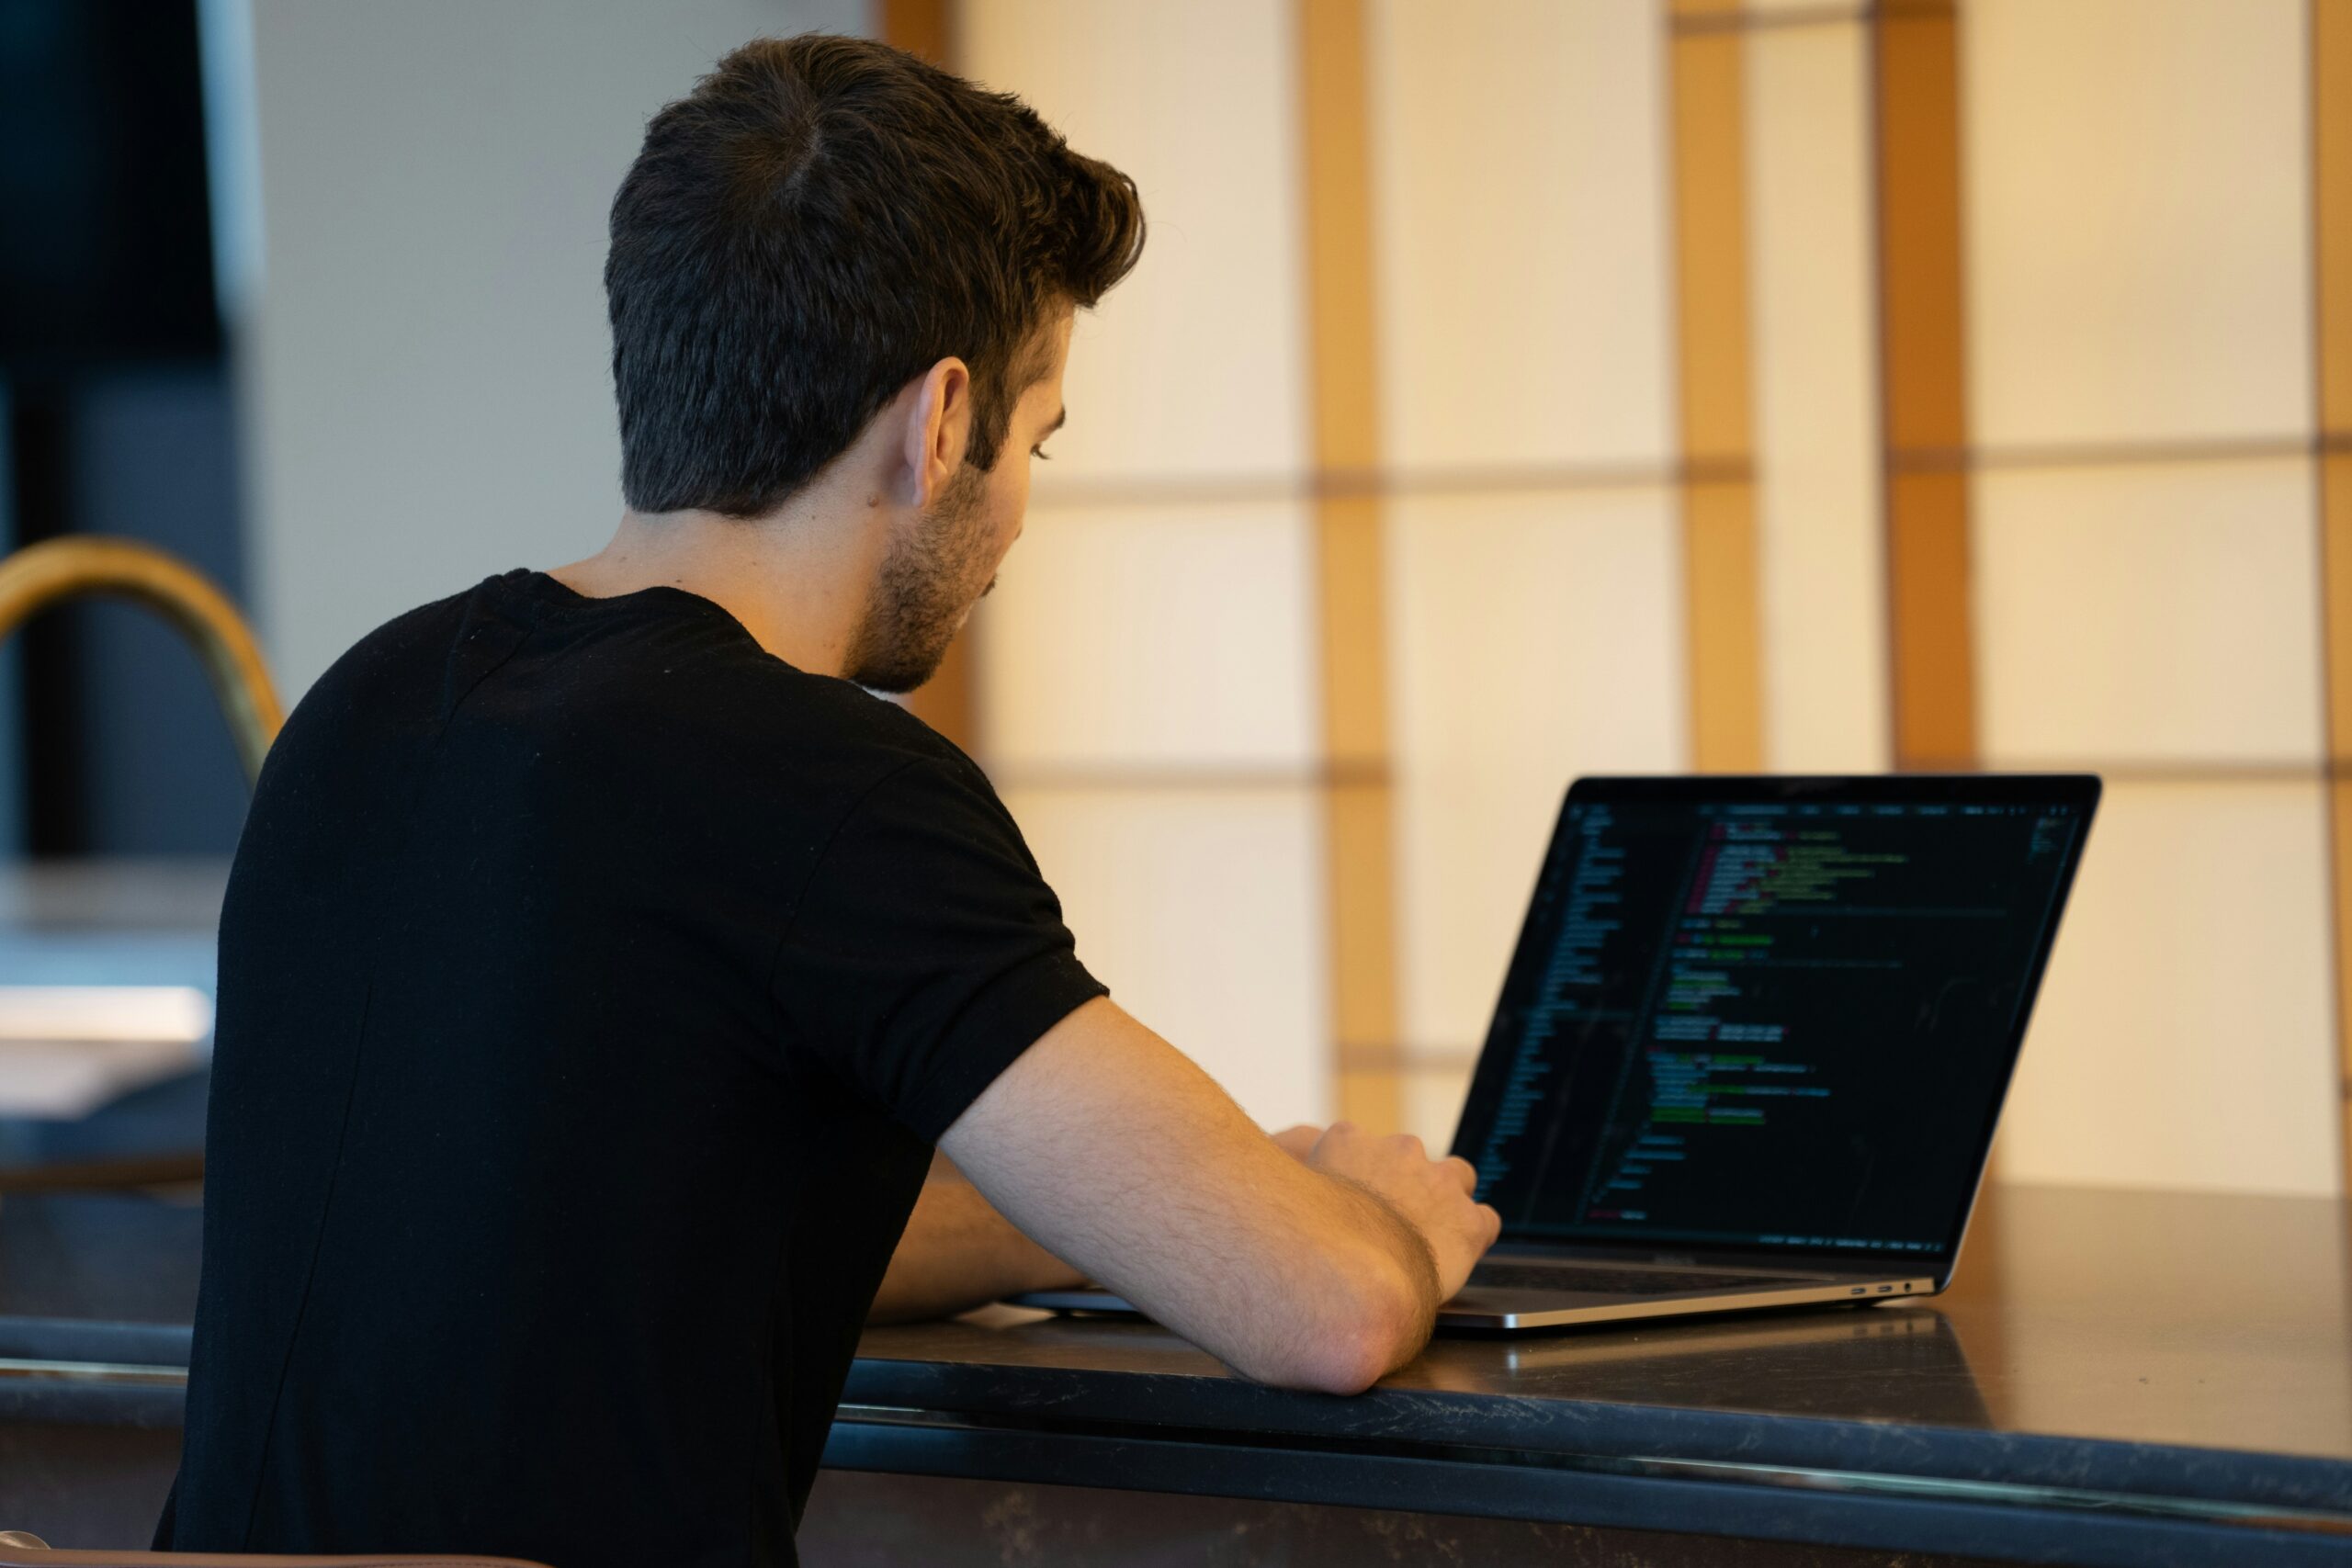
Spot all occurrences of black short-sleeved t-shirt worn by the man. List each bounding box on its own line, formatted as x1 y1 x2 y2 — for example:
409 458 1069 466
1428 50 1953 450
158 571 1103 1568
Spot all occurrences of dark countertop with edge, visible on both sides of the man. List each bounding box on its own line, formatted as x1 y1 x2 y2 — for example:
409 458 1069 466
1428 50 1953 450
0 1187 2352 1556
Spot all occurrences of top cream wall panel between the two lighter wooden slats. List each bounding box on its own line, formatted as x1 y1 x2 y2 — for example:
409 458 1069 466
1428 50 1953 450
1371 0 1672 470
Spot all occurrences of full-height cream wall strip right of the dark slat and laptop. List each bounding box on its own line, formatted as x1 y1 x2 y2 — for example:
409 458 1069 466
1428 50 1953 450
1962 0 2340 1192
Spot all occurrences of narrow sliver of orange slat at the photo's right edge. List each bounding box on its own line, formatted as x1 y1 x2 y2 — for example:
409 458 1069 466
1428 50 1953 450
2310 0 2352 1194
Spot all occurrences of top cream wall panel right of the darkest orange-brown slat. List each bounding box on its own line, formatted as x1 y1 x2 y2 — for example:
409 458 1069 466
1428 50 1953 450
1962 0 2312 449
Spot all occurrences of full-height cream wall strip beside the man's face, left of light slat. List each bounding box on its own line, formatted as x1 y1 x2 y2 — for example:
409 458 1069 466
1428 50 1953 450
959 0 1331 1123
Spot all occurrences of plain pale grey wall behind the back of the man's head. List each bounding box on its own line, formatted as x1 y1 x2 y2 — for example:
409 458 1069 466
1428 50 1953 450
243 0 865 701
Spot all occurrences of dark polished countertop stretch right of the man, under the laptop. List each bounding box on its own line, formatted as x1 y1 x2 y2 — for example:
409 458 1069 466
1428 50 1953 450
844 1187 2352 1512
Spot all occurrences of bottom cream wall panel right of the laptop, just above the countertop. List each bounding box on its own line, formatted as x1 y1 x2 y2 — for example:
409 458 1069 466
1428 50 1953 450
2002 778 2335 1194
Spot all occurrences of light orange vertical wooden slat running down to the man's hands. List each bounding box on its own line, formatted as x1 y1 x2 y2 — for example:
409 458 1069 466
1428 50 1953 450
1298 0 1402 1128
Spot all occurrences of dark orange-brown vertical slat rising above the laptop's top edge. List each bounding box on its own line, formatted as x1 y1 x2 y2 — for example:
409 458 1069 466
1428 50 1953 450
1872 0 1975 769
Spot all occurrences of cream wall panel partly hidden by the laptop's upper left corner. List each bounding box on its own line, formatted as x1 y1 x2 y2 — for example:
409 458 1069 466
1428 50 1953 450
1387 487 1687 1048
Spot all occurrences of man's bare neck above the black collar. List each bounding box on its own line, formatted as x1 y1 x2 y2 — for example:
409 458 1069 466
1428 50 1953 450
548 496 887 674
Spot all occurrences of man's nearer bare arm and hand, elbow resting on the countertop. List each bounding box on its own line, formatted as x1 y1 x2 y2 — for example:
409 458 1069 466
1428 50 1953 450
931 999 1500 1394
